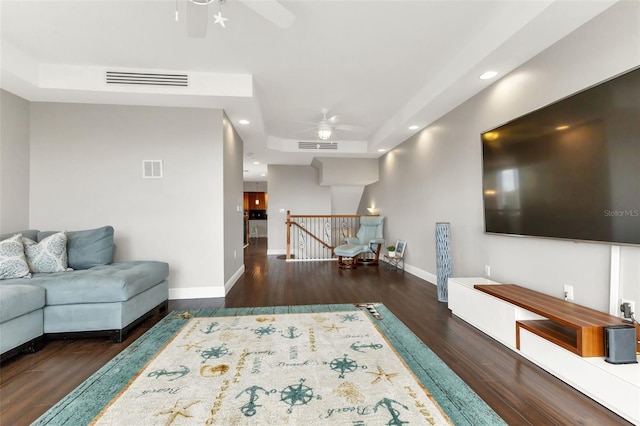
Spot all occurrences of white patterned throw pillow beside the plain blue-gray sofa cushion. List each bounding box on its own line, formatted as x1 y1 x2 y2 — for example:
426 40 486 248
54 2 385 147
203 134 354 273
22 232 69 273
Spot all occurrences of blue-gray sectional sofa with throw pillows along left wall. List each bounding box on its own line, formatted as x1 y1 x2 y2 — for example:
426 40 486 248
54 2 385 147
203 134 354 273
0 226 169 361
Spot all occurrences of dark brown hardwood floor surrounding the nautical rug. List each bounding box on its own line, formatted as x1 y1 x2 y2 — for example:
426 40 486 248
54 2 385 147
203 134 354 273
0 239 630 425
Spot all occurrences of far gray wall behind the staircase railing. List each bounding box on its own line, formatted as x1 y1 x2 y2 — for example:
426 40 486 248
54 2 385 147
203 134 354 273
267 166 331 254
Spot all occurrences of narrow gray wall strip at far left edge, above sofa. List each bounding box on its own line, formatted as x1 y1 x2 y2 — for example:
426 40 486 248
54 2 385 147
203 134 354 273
0 89 29 233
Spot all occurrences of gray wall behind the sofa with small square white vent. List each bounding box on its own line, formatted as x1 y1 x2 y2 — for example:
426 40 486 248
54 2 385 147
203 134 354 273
30 103 232 298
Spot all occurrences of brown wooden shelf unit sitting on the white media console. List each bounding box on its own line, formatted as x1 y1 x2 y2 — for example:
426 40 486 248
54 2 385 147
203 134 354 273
474 284 622 357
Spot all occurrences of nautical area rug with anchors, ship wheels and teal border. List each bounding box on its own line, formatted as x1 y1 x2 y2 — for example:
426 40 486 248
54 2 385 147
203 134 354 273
34 304 504 426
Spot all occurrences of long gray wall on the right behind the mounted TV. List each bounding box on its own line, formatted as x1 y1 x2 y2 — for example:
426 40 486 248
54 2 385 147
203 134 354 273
358 2 640 311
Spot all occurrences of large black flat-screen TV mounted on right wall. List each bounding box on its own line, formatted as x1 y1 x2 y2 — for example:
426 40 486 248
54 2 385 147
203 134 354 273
482 68 640 245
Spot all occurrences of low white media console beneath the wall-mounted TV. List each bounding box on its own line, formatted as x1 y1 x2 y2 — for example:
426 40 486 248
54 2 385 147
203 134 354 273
448 277 640 424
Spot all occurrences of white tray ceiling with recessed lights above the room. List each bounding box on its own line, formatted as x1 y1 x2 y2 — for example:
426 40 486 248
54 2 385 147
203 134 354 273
0 0 615 181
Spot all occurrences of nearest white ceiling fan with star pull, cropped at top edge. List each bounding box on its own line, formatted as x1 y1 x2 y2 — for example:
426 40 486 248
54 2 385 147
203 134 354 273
182 0 295 37
